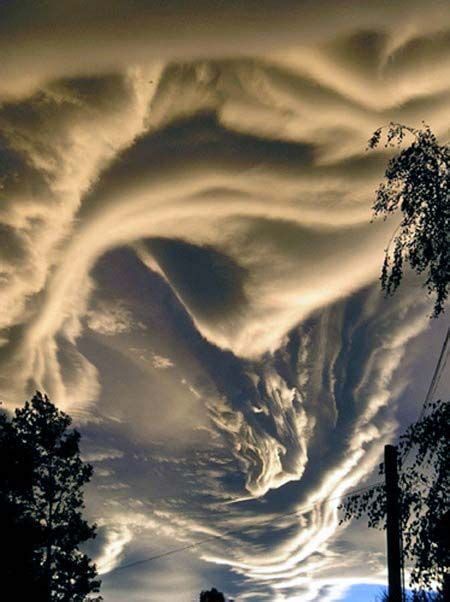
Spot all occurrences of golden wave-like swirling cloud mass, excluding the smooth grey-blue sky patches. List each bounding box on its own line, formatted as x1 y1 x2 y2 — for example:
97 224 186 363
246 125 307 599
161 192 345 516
0 1 450 600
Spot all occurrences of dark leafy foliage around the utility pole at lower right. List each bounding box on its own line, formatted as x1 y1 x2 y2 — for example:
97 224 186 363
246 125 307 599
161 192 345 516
341 401 450 600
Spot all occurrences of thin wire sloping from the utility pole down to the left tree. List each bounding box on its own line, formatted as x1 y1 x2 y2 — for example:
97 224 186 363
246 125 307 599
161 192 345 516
101 481 383 575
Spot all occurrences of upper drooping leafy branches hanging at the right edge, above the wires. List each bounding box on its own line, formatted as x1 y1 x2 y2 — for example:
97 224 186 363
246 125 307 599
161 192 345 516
368 123 450 317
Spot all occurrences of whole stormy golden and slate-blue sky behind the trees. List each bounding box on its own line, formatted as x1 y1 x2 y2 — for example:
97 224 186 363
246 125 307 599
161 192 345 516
0 0 450 602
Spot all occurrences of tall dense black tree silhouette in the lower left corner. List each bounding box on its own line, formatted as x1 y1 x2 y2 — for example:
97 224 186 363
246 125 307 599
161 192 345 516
0 393 102 602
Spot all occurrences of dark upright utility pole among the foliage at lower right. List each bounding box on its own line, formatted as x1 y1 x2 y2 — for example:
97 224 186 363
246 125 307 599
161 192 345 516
384 445 403 602
